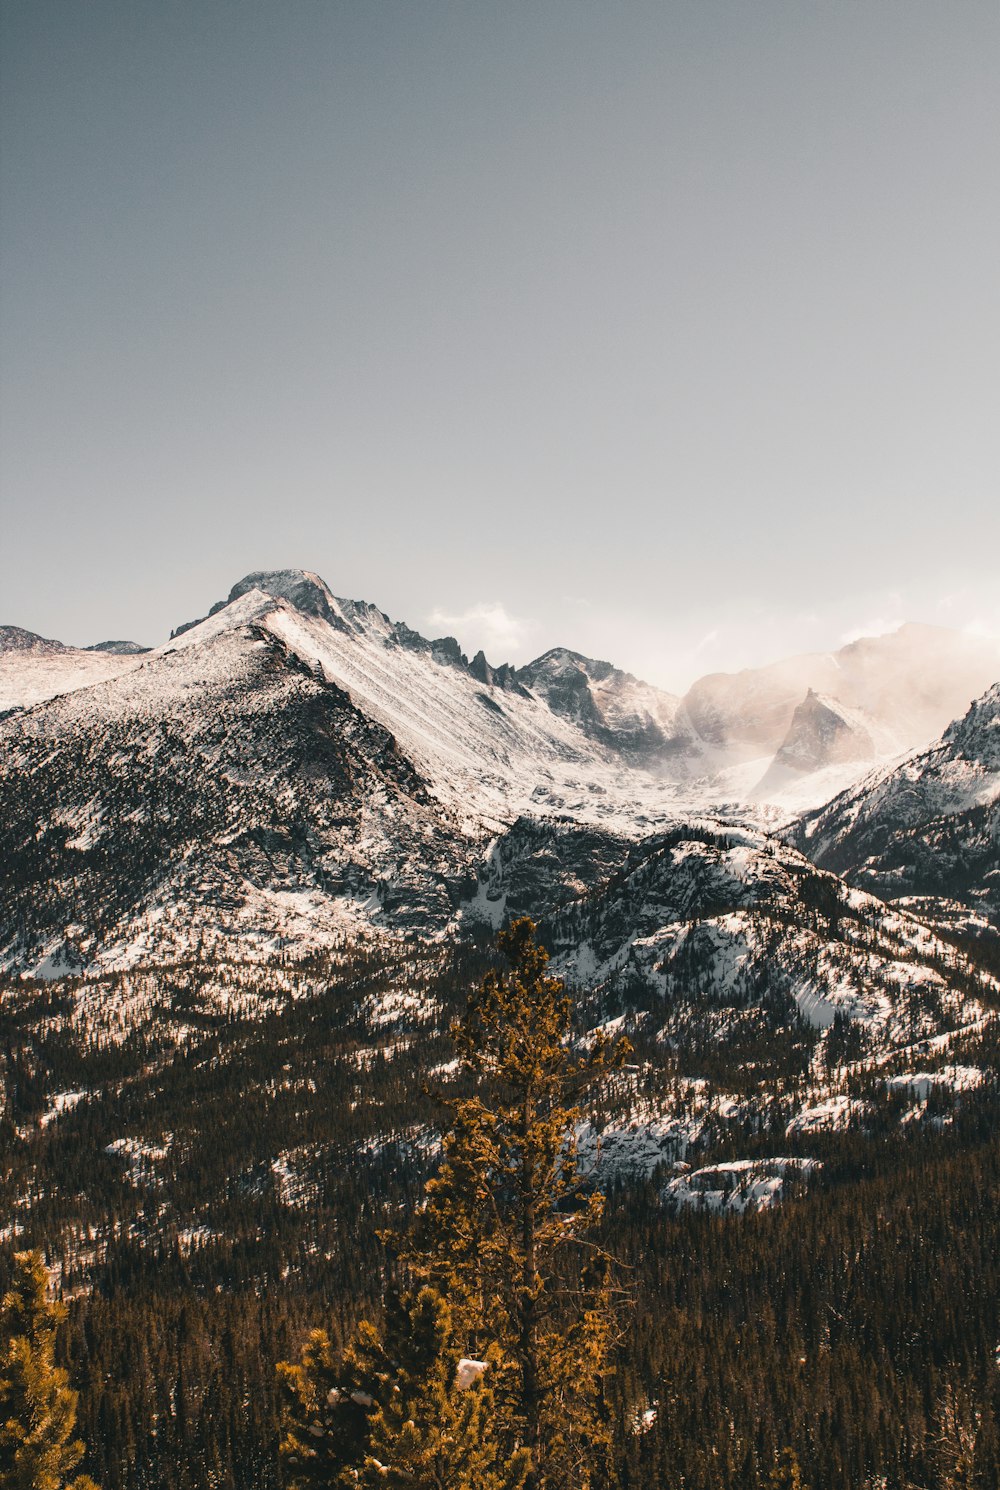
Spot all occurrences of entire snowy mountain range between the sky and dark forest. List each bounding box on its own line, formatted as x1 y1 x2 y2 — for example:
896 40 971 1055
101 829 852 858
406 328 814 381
0 571 1000 977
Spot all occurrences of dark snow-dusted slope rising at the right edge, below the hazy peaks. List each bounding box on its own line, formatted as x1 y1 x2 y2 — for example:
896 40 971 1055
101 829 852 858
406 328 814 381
793 684 1000 930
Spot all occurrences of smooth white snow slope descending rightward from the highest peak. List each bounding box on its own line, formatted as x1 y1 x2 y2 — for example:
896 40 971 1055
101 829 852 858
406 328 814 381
171 574 736 833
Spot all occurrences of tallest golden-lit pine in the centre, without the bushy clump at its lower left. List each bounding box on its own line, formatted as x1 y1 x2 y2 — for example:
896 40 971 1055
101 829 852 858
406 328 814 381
402 918 629 1490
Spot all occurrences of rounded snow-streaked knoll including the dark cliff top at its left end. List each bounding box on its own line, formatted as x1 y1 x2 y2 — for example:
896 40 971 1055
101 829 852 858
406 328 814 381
466 820 997 1061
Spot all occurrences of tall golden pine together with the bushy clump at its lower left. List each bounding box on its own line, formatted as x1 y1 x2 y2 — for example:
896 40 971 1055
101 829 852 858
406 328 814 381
279 918 627 1490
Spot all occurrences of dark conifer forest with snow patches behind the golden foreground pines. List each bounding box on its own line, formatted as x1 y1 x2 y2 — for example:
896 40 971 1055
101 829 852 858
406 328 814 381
0 929 1000 1490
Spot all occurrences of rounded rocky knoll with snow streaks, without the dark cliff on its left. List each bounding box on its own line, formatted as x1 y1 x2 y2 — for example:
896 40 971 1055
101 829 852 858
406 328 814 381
530 820 993 1043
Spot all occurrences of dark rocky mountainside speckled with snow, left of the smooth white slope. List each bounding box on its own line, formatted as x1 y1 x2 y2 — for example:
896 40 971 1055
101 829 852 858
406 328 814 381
0 616 476 976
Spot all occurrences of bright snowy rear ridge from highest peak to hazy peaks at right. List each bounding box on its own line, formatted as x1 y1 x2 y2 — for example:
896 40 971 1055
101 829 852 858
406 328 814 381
0 569 1000 817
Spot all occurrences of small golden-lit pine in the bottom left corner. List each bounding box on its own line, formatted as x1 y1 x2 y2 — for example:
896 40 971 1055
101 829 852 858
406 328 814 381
0 1252 97 1490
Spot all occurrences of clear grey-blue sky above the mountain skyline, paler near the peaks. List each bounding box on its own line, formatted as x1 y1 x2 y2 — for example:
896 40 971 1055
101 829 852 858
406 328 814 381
0 0 1000 687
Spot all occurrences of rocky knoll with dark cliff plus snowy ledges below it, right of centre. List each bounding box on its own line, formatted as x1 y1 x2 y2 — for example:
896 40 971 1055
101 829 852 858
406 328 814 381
462 820 1000 1174
